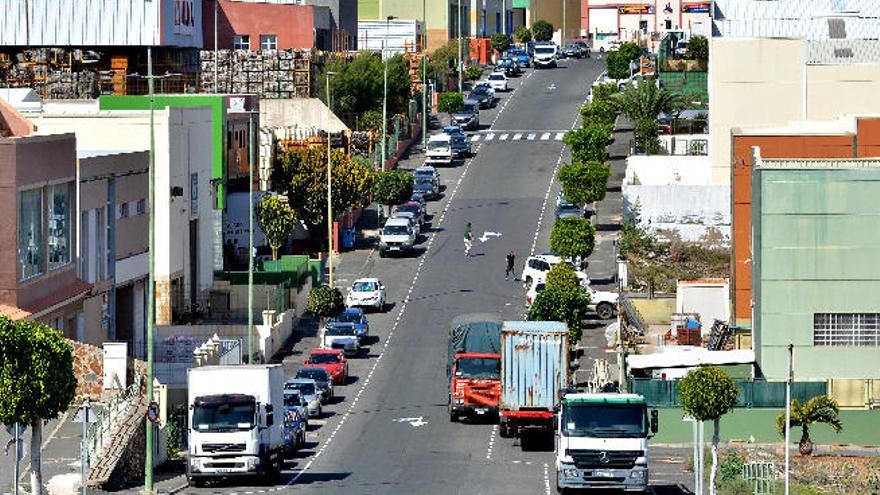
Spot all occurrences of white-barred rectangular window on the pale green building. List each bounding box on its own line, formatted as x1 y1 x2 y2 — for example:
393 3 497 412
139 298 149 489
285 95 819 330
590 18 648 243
813 313 880 347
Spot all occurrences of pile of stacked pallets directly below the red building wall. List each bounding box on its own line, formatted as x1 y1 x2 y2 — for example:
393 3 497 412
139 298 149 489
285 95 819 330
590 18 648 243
200 50 313 98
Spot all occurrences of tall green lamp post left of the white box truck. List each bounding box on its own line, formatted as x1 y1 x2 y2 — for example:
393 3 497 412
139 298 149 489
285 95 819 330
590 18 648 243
144 47 156 493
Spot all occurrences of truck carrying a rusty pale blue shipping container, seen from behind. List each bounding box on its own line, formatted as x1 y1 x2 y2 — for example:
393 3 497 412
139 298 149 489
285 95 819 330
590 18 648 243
499 321 568 445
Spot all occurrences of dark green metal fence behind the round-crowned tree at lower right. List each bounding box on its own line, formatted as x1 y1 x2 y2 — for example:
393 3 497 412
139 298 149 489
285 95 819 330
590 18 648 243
629 380 828 408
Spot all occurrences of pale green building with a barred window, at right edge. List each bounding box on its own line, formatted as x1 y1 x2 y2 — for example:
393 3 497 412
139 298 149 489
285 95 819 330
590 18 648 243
751 156 880 380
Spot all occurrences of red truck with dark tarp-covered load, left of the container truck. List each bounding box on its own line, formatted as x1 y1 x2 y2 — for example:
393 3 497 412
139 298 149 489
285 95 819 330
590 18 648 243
446 318 501 422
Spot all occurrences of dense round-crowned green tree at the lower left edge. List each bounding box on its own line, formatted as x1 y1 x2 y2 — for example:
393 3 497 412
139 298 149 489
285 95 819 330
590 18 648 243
0 316 76 495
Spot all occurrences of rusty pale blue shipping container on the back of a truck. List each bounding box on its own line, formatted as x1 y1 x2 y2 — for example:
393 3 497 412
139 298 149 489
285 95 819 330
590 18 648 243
500 321 568 411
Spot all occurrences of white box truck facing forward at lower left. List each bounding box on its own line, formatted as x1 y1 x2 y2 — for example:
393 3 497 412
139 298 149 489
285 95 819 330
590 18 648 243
186 364 285 486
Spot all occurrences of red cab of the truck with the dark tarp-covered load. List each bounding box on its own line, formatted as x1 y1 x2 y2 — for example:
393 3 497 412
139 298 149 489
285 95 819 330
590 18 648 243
449 352 501 421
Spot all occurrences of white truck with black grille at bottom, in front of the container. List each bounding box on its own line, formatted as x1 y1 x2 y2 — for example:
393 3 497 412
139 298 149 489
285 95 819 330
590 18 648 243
556 393 657 493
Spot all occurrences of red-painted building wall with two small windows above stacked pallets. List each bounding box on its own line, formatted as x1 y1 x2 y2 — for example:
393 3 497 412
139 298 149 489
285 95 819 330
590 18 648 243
202 0 314 50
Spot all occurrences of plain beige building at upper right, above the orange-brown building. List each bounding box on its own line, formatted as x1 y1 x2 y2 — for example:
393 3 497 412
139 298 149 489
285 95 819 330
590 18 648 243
709 38 880 184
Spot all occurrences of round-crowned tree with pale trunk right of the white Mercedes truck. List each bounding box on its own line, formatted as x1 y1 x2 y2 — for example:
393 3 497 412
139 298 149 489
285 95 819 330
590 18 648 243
678 366 737 495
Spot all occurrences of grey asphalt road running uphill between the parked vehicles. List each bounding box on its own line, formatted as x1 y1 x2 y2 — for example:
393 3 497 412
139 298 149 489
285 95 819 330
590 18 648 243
115 56 696 495
